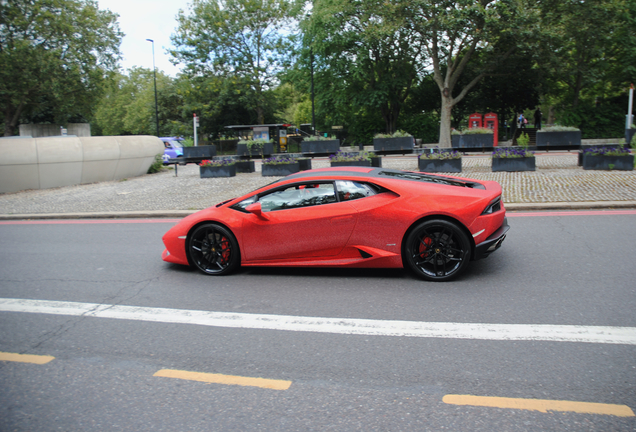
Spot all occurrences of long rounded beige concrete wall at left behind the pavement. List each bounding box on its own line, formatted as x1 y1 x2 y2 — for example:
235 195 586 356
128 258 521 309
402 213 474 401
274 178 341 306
0 136 164 193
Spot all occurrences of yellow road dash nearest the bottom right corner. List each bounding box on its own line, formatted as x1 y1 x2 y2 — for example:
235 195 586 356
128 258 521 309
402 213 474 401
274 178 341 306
442 395 634 417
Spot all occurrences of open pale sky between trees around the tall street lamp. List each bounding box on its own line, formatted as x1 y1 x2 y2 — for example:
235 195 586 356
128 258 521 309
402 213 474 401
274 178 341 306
97 0 190 76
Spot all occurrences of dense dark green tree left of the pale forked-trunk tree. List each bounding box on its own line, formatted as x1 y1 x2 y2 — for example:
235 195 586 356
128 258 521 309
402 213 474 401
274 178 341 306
304 0 425 133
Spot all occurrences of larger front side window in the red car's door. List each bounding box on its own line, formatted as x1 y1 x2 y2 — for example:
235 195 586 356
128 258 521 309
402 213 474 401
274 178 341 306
258 183 336 212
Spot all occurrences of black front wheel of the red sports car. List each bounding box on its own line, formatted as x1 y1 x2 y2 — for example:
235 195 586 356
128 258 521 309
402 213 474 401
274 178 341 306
188 223 241 276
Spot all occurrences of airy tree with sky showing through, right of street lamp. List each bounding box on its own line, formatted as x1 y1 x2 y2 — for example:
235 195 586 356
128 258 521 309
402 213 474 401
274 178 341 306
171 0 294 124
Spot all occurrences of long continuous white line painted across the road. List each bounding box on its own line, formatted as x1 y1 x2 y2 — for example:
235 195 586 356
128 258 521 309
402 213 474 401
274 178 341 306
0 298 636 345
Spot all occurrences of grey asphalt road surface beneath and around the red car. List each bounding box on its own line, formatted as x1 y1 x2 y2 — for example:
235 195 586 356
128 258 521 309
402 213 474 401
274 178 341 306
0 211 636 431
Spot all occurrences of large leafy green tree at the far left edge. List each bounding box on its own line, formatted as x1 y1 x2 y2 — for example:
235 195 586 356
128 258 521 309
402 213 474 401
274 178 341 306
0 0 123 136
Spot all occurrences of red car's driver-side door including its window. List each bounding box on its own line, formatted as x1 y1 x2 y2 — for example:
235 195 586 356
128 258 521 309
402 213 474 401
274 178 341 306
241 182 357 261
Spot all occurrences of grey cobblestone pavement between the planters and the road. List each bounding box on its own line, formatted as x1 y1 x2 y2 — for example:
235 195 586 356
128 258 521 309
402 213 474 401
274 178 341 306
0 153 636 216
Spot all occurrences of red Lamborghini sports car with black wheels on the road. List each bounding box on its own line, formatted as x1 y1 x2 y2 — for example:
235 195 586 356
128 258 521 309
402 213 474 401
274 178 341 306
163 167 509 281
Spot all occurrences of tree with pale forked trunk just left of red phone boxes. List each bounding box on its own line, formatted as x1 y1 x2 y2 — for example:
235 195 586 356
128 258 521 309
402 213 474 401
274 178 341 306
412 0 533 147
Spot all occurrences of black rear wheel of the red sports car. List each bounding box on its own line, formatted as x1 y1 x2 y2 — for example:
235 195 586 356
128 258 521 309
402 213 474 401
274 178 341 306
404 219 470 282
